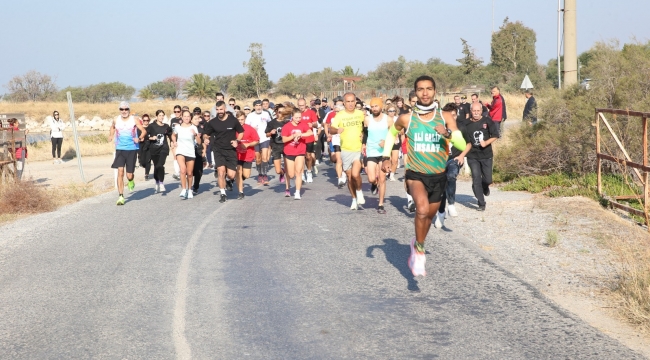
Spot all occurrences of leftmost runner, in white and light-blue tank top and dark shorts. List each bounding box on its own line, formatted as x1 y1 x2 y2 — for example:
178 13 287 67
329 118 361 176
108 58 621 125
110 101 147 205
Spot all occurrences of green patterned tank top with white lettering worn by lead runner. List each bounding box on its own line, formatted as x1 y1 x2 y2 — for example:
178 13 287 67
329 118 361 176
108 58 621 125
406 109 449 175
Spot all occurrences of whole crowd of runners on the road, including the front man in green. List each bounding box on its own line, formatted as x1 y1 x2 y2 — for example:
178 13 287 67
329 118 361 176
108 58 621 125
111 76 505 276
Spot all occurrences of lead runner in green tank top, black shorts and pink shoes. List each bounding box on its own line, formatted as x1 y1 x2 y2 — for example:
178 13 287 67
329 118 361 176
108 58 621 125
382 75 467 276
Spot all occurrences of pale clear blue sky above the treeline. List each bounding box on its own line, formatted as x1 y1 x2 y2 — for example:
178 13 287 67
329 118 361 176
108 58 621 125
0 0 650 90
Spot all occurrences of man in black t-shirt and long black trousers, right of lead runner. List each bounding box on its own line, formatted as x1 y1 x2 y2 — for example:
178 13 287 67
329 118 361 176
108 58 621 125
462 102 499 211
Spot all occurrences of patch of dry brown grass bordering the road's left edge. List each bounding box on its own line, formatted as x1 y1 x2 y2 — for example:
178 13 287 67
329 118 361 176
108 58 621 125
0 180 103 223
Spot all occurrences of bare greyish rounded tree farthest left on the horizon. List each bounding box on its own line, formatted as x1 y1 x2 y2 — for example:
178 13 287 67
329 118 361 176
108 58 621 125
6 70 57 101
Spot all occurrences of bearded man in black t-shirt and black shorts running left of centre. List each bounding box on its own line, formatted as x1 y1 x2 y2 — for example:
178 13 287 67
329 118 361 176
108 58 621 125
203 101 244 203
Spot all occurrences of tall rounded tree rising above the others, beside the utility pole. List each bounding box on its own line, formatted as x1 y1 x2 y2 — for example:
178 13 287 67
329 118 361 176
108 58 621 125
490 18 537 74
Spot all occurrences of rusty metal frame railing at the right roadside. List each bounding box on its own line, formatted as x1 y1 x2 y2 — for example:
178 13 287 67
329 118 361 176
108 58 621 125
595 109 650 231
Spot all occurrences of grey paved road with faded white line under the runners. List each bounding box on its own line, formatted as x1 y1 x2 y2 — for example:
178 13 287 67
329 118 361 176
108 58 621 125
0 166 641 359
